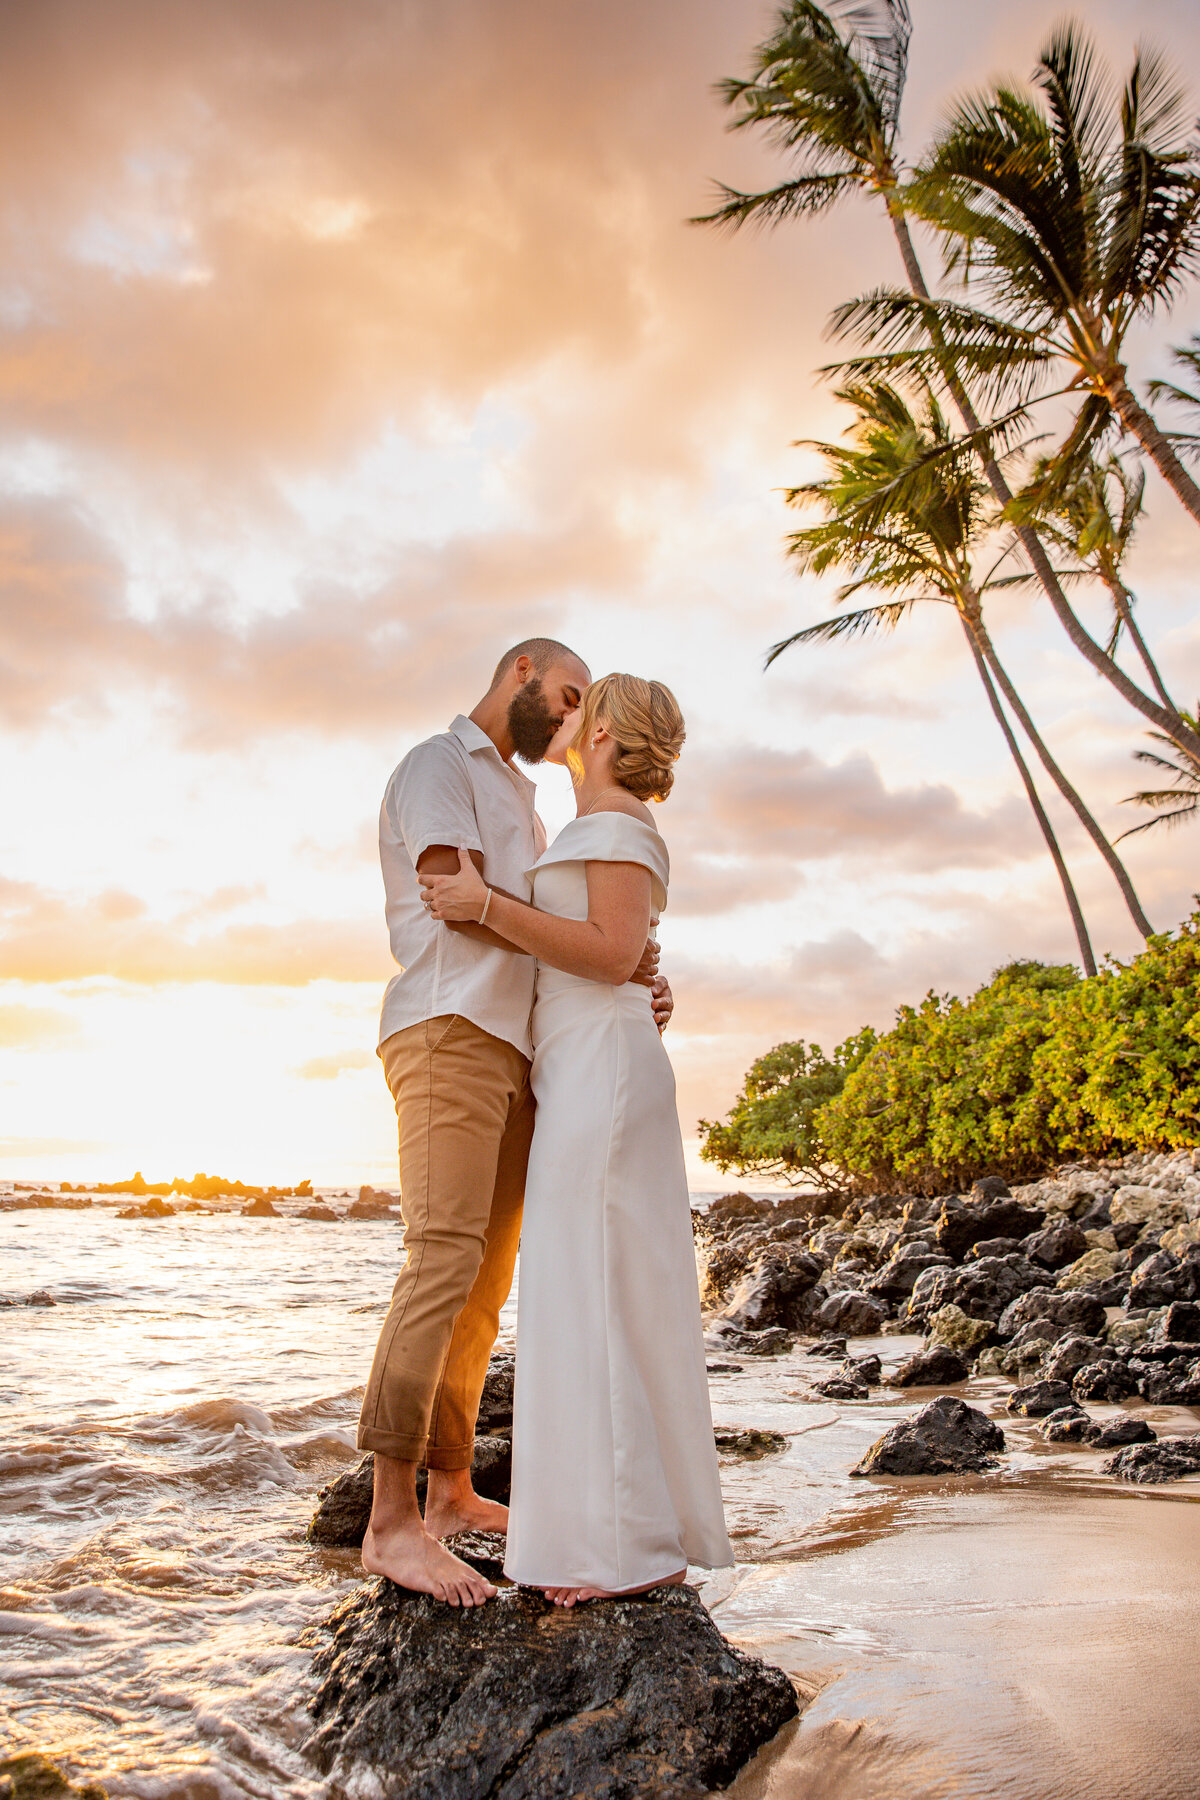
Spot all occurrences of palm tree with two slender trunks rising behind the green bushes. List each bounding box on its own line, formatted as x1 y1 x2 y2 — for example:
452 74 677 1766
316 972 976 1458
780 382 1150 974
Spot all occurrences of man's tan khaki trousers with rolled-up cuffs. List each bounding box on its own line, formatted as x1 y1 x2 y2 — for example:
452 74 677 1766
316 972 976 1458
358 1015 534 1469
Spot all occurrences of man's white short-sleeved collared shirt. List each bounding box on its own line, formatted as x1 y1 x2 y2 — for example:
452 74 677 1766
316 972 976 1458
380 715 545 1057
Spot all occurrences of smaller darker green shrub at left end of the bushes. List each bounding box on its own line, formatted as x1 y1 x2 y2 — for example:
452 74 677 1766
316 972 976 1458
700 1026 878 1186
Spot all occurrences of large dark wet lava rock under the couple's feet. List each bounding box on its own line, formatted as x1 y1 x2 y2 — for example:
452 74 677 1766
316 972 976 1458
304 1580 799 1800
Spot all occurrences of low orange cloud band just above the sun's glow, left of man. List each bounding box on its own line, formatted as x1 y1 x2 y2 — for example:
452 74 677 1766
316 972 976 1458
0 878 394 986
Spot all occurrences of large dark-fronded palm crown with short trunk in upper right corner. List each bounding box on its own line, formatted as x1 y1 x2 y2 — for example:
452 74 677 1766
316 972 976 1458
907 23 1200 520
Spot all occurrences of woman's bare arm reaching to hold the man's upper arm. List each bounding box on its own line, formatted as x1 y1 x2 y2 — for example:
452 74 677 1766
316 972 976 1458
421 850 649 988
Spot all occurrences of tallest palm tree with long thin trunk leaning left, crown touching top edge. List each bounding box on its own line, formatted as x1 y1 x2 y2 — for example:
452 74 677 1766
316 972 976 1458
696 0 1200 781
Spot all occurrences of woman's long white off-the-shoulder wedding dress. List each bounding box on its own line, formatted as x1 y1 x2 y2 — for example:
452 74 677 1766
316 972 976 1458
504 812 734 1588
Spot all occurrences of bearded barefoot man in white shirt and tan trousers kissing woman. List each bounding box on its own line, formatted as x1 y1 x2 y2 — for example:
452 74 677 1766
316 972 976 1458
358 637 673 1606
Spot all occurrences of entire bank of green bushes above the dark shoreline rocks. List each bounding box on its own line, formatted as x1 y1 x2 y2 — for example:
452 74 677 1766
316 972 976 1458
700 913 1200 1193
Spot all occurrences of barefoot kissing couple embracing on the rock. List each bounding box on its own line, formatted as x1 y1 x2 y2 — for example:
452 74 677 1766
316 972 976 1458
358 639 734 1606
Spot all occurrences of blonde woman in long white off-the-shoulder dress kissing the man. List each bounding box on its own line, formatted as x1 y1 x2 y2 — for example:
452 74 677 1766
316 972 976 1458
423 675 734 1606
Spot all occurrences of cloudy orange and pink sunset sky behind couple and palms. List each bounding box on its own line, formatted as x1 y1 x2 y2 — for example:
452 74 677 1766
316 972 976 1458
0 0 1200 1186
